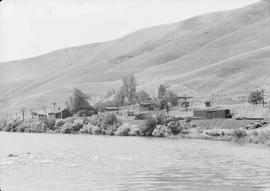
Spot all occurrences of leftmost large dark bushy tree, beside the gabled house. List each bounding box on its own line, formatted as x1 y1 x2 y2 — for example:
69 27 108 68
70 88 93 113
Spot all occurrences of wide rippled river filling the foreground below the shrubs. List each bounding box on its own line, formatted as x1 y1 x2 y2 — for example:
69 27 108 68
0 132 270 191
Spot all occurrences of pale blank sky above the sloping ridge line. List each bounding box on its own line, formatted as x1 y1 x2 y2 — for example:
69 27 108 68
0 0 258 62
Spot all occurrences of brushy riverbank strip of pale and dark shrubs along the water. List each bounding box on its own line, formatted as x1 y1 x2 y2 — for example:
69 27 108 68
0 113 270 146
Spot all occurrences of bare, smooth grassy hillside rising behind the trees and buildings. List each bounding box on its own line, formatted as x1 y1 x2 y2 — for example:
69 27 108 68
0 0 270 111
